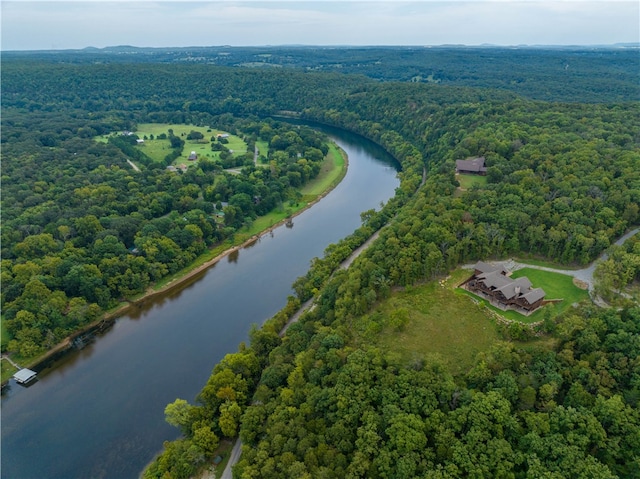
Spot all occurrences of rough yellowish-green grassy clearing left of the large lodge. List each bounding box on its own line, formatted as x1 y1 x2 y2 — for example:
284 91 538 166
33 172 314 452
362 271 501 375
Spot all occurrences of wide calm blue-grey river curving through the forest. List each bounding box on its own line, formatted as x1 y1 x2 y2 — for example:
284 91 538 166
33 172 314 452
1 125 399 479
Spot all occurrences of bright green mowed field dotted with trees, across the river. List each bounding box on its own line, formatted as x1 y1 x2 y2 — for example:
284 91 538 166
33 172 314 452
135 123 247 165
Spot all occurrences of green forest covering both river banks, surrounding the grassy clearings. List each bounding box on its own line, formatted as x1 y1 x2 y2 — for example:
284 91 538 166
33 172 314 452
2 49 640 478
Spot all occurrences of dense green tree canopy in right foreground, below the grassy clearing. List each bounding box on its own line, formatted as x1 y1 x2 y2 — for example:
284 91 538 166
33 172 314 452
235 308 640 478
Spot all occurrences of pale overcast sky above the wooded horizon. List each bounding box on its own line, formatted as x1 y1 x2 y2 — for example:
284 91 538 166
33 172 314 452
1 0 640 50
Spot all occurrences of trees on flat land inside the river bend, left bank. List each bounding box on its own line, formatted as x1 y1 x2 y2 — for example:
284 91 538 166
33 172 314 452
1 107 336 358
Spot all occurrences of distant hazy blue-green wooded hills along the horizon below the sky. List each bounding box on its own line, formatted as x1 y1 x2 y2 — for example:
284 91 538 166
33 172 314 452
3 46 640 103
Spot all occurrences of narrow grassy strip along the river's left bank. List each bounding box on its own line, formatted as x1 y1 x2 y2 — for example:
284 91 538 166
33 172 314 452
2 141 349 387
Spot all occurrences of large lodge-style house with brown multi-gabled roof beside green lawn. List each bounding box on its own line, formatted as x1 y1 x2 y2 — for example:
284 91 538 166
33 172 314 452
462 261 546 315
